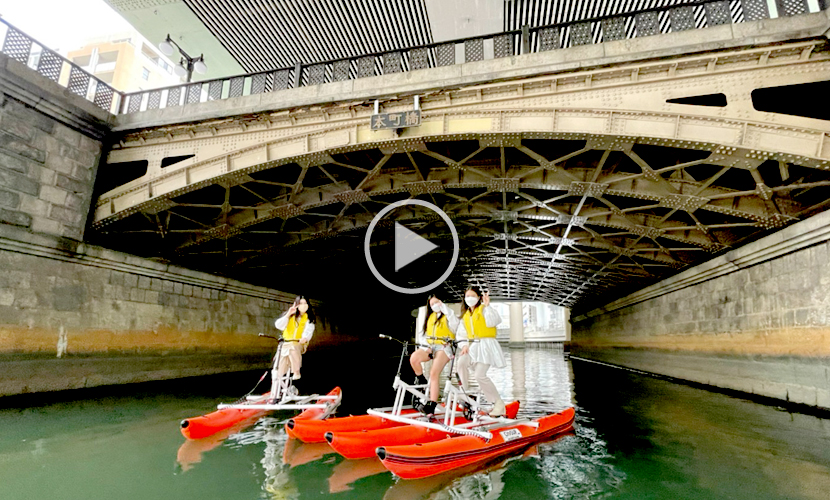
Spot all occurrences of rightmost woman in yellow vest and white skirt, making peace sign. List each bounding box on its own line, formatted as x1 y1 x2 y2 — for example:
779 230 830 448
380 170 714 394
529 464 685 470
458 286 505 417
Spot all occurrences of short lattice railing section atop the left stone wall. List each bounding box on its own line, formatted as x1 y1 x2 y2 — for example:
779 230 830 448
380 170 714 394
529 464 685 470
0 18 124 114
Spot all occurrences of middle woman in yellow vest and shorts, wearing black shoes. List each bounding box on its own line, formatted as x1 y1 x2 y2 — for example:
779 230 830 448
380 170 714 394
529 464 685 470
409 295 458 415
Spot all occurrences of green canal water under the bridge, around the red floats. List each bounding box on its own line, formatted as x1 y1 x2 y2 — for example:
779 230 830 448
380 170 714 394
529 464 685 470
0 349 830 500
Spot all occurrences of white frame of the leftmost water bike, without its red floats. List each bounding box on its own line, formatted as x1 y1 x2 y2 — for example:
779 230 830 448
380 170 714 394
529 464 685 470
217 333 343 412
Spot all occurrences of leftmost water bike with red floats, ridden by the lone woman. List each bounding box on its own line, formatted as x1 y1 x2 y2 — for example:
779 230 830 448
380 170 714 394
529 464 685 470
181 333 343 439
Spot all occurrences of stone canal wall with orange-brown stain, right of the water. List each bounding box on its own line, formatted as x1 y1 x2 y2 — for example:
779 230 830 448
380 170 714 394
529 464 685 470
571 213 830 408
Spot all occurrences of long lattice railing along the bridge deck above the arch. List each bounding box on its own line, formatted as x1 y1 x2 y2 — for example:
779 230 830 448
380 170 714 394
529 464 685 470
120 0 826 113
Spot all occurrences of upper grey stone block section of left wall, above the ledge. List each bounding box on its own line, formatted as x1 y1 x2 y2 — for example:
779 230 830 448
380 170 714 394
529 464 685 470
0 55 108 241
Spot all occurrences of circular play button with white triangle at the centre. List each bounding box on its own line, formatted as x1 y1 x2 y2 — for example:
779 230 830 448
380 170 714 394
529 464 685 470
363 200 458 294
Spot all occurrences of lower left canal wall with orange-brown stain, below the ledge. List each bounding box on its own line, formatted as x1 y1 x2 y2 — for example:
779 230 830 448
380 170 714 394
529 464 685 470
0 225 335 396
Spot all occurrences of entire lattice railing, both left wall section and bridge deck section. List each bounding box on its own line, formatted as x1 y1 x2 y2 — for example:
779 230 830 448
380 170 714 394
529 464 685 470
0 0 830 114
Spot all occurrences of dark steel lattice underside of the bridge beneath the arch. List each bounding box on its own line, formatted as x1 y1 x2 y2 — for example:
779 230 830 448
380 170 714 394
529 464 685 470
94 129 830 306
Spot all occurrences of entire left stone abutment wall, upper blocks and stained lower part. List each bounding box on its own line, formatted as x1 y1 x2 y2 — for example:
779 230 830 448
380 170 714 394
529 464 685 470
0 55 344 396
